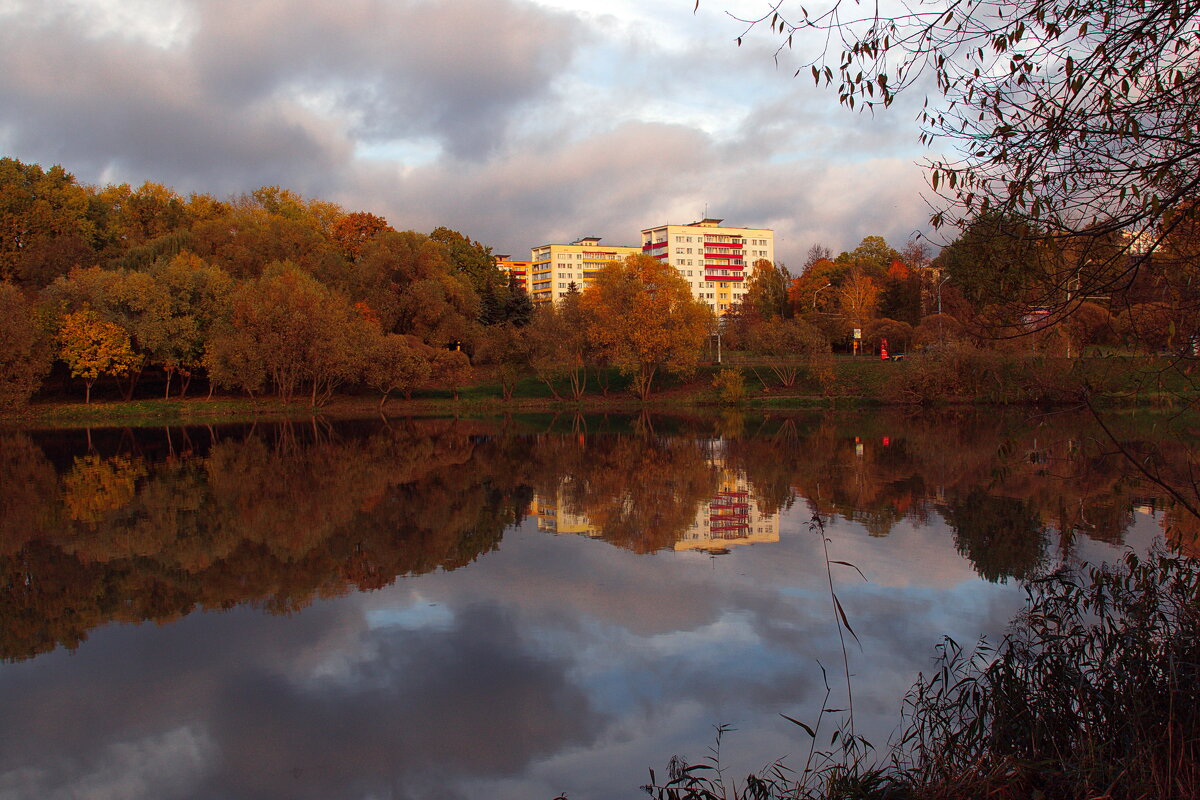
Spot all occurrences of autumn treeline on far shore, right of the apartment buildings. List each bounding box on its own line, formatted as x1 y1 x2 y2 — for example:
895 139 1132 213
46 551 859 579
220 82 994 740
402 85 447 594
758 214 1200 357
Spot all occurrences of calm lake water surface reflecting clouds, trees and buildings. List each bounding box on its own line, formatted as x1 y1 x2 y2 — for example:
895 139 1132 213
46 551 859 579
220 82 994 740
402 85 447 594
0 413 1180 800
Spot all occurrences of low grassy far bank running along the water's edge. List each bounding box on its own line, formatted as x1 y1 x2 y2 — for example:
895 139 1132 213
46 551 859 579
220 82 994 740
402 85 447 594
0 356 1195 427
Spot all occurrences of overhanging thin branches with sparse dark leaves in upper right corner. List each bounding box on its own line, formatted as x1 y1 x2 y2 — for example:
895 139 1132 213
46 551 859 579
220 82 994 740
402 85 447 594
729 0 1200 331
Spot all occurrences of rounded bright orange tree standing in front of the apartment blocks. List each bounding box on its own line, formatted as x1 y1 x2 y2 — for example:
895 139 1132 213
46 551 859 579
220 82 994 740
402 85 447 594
582 255 715 401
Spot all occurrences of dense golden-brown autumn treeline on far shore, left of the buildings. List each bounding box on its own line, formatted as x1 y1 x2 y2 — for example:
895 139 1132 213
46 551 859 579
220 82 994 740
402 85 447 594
0 158 533 405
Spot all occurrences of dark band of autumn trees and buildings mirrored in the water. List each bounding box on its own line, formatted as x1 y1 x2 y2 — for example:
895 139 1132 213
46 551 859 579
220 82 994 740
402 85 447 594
0 413 1198 660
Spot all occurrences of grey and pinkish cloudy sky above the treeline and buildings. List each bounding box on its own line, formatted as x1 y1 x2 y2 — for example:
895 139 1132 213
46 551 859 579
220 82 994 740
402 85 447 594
0 0 929 266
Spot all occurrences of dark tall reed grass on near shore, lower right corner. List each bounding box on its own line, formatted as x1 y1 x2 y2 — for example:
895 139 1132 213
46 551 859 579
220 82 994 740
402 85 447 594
643 549 1200 800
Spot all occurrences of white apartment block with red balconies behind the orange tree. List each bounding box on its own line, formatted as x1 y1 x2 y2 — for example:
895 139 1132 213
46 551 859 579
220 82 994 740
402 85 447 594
642 219 775 314
